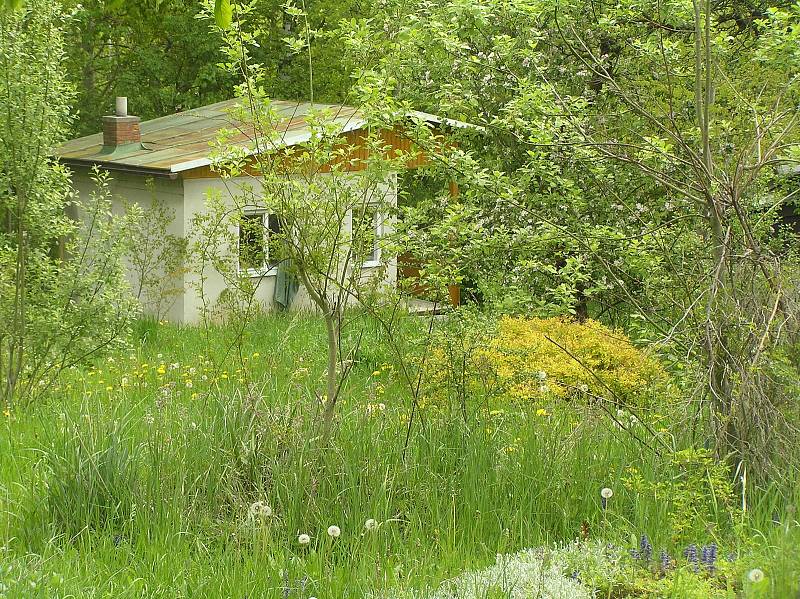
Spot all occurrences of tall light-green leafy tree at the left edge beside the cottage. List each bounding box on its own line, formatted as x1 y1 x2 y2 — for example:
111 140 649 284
0 0 134 403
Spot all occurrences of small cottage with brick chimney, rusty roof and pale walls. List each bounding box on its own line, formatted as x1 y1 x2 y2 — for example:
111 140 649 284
57 98 465 323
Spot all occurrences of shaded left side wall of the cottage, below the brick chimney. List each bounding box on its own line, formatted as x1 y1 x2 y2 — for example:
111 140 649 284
72 168 187 322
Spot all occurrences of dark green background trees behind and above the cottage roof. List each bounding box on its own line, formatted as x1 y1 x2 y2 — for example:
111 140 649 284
60 0 366 134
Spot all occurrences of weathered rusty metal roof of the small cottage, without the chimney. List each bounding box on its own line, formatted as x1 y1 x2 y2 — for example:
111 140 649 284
56 98 476 176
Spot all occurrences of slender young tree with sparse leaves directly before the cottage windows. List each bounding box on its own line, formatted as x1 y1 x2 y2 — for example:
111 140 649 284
197 3 416 442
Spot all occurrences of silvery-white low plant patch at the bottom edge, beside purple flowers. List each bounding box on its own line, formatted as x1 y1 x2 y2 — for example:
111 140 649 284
373 549 592 599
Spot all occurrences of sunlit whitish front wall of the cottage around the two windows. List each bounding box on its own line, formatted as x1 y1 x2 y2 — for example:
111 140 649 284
182 173 404 323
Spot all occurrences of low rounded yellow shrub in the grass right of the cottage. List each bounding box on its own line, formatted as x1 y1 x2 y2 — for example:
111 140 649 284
425 317 666 404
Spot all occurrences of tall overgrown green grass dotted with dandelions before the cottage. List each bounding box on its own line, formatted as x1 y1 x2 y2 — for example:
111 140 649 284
0 315 800 598
